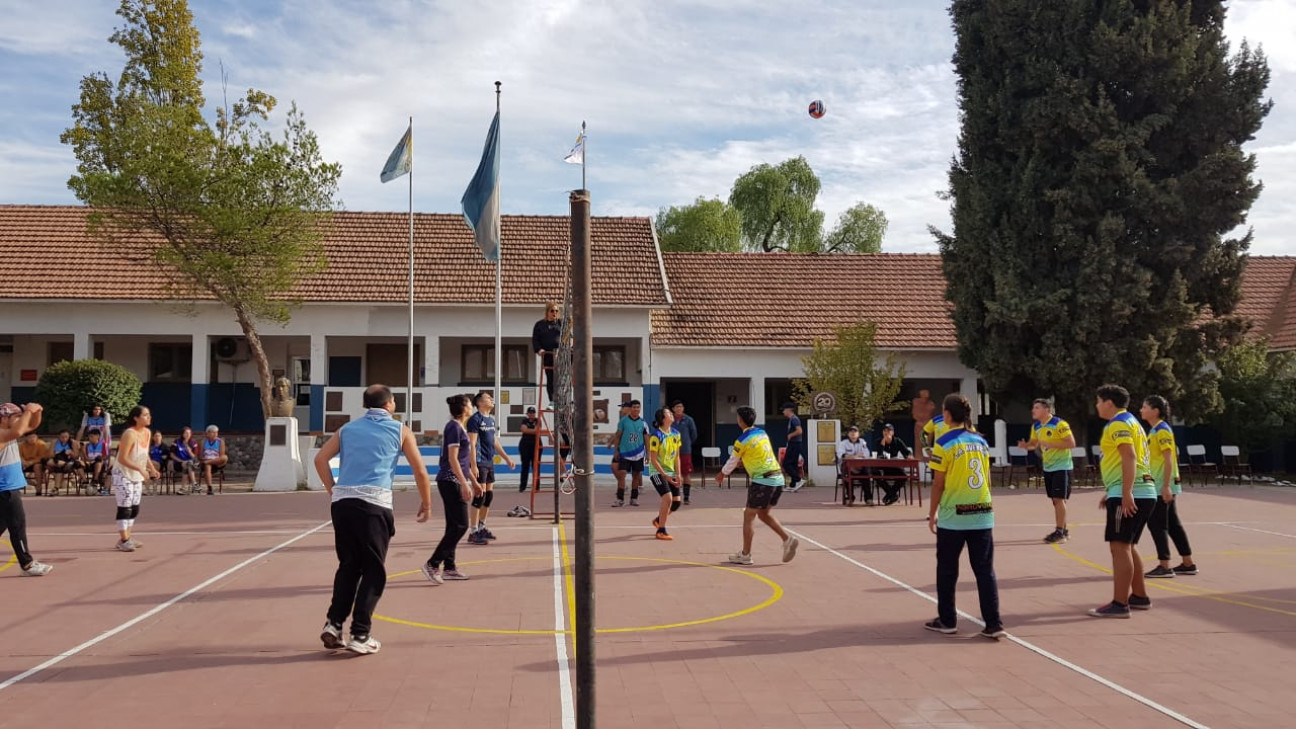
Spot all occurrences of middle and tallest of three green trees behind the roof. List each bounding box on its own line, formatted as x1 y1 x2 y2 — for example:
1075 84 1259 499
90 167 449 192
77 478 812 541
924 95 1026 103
730 157 823 253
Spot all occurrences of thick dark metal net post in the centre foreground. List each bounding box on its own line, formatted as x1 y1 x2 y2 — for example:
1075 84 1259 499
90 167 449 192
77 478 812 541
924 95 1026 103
572 189 595 729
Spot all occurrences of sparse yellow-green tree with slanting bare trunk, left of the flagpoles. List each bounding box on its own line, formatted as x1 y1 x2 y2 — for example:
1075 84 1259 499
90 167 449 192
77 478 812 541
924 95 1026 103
62 0 341 415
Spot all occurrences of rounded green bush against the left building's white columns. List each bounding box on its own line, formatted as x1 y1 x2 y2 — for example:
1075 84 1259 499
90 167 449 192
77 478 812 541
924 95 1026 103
32 359 143 432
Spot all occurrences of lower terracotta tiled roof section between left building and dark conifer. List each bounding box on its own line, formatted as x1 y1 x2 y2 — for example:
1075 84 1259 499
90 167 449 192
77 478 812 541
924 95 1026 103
652 253 956 349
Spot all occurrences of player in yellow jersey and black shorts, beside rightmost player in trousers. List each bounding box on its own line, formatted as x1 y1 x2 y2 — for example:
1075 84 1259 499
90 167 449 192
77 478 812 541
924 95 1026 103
1089 385 1156 617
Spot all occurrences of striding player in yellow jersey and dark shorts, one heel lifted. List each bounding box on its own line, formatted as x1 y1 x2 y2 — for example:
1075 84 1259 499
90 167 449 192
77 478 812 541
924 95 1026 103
715 406 801 564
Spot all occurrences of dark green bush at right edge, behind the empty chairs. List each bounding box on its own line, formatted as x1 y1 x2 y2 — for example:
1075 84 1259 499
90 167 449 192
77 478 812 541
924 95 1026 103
1209 341 1296 453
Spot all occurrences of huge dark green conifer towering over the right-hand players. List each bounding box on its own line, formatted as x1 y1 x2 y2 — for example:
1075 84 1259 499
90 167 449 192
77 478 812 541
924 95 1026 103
933 0 1270 419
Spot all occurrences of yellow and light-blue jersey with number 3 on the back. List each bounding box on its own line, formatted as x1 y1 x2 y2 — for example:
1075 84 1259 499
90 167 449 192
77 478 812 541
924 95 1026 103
928 428 994 529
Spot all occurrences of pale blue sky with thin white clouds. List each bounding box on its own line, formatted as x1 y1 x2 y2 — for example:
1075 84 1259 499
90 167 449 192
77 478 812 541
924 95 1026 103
0 0 1296 254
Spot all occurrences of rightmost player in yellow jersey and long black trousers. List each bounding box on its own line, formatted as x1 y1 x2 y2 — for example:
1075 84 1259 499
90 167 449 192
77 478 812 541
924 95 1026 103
1139 394 1198 577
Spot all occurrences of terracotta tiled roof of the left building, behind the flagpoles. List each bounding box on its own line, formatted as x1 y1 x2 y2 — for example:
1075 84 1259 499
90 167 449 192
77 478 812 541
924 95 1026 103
0 205 669 306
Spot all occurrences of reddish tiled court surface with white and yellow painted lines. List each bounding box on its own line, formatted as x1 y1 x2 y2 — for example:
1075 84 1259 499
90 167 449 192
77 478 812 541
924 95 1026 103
0 486 1296 729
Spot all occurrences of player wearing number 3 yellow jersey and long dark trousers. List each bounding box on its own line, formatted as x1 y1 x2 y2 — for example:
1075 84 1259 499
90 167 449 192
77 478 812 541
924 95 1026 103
923 393 1004 638
